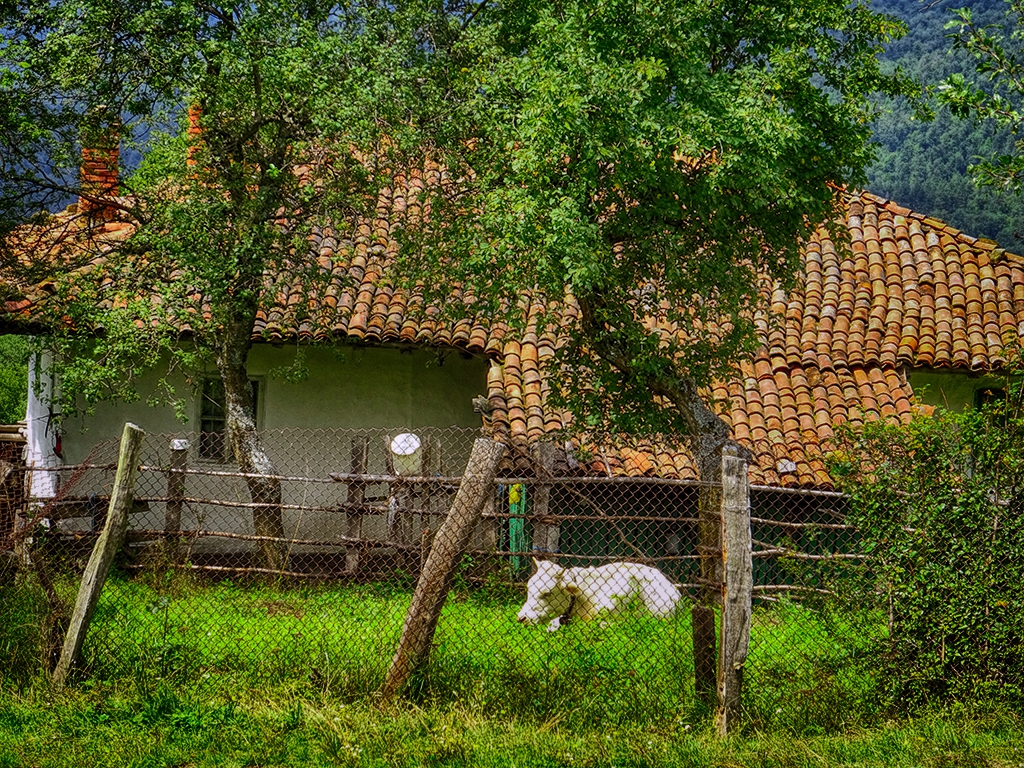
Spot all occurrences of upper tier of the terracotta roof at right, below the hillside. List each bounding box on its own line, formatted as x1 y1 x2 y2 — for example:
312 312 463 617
765 193 1024 371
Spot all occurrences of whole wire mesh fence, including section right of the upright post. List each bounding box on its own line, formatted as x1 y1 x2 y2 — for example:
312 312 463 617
0 429 978 728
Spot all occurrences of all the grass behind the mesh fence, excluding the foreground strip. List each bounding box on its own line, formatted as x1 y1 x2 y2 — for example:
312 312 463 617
0 574 921 733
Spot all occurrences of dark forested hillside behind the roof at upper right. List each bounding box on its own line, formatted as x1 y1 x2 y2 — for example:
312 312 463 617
868 0 1024 253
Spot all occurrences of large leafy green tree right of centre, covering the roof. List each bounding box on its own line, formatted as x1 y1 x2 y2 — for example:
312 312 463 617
395 0 909 487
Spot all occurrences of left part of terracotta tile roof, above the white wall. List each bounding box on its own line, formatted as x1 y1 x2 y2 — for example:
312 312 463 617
0 188 507 355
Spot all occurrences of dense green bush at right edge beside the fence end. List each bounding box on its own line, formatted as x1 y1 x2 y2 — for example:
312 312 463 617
829 382 1024 707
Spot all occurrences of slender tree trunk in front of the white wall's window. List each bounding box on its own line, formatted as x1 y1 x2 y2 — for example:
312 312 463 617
216 322 288 570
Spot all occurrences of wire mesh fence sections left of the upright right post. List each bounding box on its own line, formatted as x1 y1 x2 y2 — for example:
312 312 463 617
18 430 720 711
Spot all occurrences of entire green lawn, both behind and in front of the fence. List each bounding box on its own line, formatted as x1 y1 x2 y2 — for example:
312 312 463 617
0 574 1024 768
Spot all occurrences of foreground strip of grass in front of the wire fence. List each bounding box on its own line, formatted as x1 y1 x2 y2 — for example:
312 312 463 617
0 683 1024 768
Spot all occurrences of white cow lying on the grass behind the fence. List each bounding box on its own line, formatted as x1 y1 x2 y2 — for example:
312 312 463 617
516 558 680 632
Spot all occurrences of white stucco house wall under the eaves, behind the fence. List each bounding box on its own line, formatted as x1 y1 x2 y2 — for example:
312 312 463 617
34 345 489 554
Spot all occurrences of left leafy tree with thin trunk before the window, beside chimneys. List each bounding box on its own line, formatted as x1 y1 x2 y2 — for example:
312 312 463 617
0 0 458 568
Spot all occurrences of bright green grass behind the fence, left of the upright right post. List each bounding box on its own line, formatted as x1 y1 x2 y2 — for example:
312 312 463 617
12 575 699 723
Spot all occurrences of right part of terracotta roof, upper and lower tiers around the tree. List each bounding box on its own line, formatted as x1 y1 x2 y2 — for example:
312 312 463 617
487 193 1024 487
